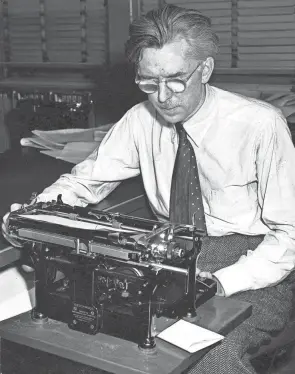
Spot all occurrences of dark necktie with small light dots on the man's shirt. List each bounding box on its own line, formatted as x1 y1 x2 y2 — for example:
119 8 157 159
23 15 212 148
169 123 206 232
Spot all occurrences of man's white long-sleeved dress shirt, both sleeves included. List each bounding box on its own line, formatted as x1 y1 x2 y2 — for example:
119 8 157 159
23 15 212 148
38 85 295 296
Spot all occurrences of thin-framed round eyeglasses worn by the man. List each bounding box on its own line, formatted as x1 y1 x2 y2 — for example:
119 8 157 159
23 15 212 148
135 61 203 94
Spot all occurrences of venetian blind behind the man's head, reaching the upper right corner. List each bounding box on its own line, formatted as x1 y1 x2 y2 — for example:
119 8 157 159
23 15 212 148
141 0 295 72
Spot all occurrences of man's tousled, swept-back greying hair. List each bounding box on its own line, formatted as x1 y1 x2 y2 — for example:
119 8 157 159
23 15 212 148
125 5 218 64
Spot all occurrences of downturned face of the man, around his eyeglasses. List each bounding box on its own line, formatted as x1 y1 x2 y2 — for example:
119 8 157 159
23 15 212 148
137 40 204 123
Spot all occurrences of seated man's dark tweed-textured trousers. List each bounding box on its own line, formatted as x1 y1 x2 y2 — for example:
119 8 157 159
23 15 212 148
187 234 293 374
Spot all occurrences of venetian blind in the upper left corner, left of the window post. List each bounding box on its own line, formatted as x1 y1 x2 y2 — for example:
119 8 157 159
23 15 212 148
0 0 107 64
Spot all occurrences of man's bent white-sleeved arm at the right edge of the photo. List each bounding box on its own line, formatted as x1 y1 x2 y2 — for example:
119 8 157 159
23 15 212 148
214 109 295 296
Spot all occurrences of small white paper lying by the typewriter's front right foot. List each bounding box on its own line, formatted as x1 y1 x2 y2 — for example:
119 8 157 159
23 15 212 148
157 319 224 353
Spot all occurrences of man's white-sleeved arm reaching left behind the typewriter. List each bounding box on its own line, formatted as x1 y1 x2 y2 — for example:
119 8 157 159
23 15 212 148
37 108 139 206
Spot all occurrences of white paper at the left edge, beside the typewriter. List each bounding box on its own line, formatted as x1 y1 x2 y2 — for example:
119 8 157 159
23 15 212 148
0 267 35 321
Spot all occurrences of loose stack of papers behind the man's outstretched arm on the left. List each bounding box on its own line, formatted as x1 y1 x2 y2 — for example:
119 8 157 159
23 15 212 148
21 123 113 164
